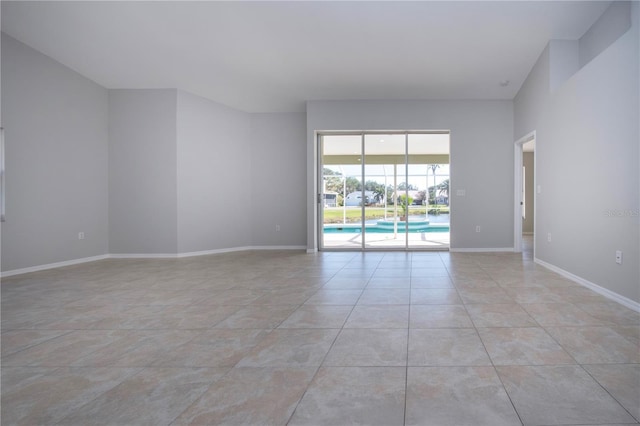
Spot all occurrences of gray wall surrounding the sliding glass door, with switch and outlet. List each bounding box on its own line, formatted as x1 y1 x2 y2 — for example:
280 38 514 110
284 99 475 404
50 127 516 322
307 101 514 250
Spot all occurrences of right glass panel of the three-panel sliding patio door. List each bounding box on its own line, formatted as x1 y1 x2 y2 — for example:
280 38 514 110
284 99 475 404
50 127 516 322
407 133 450 248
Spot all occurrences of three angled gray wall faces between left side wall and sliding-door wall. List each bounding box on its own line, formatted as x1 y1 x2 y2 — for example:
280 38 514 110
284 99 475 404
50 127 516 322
110 90 306 254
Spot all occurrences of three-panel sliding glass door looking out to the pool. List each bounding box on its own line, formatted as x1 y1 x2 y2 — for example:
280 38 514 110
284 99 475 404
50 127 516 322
318 131 450 250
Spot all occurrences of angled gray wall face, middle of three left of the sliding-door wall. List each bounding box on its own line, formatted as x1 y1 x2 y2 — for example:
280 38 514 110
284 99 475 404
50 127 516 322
177 91 255 253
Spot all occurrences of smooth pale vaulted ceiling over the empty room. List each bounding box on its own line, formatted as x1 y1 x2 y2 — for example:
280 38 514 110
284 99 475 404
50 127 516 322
2 1 610 112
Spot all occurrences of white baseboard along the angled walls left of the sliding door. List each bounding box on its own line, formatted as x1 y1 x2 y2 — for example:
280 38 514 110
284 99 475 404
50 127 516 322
0 246 307 278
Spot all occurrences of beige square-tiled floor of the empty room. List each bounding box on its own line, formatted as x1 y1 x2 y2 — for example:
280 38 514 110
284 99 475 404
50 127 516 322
2 241 640 426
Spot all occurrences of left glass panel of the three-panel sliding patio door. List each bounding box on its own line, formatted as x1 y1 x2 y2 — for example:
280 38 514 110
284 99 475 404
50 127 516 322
321 135 362 249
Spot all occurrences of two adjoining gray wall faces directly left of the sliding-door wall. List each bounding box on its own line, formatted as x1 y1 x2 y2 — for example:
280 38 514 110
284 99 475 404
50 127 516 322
177 91 306 253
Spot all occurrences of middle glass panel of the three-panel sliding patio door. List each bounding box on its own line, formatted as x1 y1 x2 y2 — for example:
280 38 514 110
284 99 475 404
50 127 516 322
363 134 407 248
